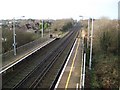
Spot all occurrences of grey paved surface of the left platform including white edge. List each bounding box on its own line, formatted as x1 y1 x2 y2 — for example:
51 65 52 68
0 38 55 73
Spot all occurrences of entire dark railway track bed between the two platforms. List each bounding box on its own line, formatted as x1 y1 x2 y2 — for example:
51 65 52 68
3 23 80 88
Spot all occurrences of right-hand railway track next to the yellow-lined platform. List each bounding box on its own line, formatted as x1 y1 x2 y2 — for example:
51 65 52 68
32 28 77 90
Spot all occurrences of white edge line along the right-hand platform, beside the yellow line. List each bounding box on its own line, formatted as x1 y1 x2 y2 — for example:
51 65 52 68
54 39 77 89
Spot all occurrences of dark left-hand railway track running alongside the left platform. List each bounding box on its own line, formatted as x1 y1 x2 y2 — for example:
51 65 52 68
2 41 57 88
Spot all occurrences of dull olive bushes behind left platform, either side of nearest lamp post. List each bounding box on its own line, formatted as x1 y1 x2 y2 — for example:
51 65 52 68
2 29 37 53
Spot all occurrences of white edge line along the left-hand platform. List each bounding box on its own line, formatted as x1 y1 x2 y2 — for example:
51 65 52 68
0 39 55 74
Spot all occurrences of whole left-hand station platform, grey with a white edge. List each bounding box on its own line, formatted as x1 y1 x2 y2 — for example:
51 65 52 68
0 38 56 74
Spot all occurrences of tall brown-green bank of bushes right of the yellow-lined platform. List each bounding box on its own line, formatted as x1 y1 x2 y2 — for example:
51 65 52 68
88 18 120 88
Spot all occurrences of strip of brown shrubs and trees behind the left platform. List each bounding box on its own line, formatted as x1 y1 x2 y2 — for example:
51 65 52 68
2 19 74 53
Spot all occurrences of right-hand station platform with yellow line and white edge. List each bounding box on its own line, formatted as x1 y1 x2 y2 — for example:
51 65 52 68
55 31 82 90
